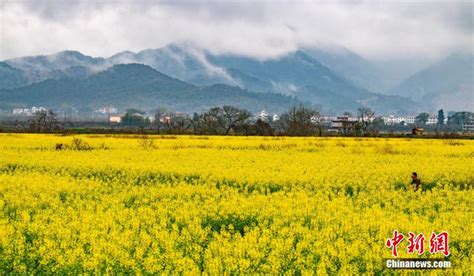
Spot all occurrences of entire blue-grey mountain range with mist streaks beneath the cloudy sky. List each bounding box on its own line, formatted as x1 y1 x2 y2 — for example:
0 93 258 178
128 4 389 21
0 45 473 114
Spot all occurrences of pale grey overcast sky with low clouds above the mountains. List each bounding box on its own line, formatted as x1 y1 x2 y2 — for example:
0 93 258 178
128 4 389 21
0 0 474 59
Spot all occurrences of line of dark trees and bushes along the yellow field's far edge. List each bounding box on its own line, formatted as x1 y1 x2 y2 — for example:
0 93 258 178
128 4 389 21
6 105 474 136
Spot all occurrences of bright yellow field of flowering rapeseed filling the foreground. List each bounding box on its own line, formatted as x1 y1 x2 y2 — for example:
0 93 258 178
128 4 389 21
0 134 474 274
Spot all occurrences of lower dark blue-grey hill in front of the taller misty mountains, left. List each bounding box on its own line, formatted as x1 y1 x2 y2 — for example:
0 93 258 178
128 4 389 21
0 64 298 112
